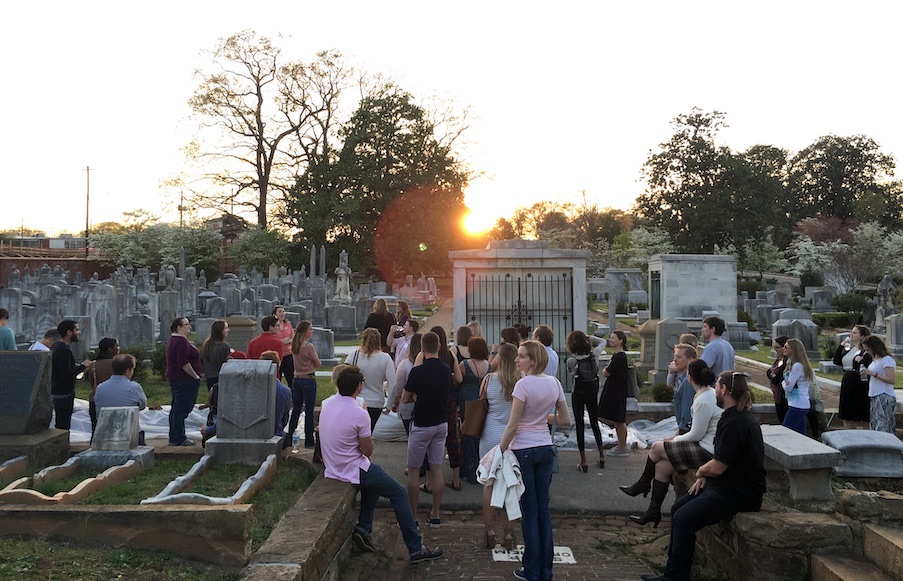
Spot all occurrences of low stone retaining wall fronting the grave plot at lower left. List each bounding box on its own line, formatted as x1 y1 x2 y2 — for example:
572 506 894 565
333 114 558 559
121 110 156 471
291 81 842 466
0 504 251 567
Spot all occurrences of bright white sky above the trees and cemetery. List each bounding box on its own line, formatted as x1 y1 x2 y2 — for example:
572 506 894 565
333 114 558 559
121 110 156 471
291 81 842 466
0 0 903 235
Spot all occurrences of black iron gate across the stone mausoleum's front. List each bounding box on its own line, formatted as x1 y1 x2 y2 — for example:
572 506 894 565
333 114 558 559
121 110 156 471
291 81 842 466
466 270 574 386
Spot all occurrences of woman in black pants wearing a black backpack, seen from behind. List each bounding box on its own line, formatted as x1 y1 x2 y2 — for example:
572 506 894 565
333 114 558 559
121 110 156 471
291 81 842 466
565 331 605 472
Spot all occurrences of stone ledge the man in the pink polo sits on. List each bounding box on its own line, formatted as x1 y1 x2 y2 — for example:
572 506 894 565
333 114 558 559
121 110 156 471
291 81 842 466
244 474 357 581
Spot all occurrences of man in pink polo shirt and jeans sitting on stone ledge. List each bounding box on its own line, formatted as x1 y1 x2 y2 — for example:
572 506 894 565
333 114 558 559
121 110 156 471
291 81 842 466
320 365 442 563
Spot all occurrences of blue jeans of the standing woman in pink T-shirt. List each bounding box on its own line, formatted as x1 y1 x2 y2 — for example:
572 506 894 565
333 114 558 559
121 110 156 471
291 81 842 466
513 446 555 581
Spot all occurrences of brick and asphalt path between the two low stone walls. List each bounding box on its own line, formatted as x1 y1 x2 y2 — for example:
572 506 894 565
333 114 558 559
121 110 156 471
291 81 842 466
341 442 674 581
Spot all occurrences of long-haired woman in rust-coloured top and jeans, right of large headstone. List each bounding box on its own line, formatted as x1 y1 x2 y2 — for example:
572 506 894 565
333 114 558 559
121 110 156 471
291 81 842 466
286 321 320 448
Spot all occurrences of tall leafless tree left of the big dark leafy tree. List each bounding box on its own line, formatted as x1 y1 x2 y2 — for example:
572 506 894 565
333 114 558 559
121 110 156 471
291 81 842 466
186 30 353 228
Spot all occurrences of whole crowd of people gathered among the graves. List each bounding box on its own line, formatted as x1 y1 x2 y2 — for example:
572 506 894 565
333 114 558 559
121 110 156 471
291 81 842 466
7 299 896 581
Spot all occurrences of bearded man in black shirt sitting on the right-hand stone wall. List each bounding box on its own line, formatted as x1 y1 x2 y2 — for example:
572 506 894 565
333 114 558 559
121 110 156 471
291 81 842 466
642 371 765 581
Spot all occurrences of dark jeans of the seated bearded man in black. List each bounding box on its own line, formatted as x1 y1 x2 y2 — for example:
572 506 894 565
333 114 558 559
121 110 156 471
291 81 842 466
664 484 764 581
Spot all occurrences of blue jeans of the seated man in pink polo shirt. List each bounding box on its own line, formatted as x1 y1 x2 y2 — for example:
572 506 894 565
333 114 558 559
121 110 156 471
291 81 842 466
355 463 423 557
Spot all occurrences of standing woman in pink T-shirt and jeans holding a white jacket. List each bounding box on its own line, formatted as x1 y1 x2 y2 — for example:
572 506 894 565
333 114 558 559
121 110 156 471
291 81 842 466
499 340 571 581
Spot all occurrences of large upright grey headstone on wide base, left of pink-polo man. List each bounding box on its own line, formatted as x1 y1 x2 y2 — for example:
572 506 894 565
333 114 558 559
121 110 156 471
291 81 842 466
206 359 282 464
